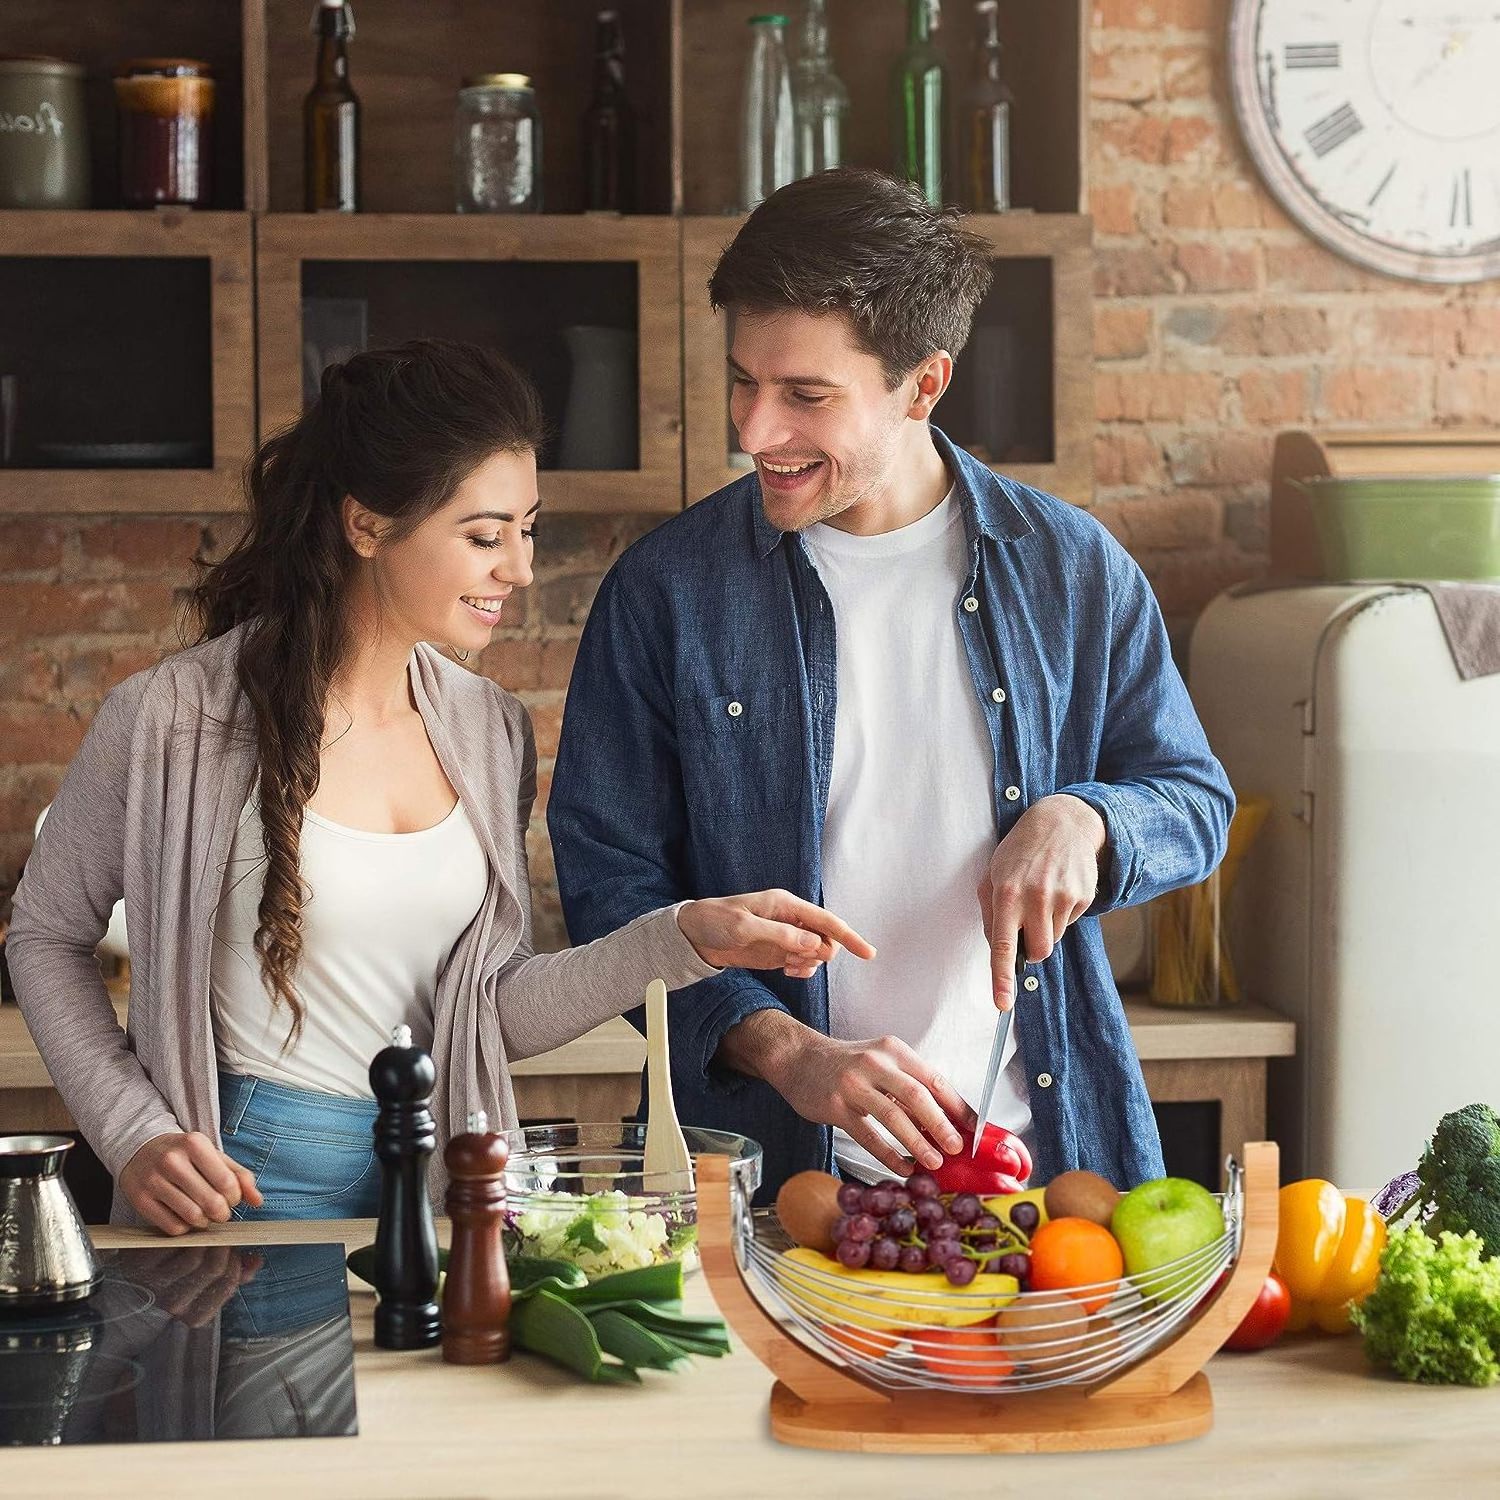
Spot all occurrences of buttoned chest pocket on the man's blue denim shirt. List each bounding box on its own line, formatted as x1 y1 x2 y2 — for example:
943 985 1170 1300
680 684 804 816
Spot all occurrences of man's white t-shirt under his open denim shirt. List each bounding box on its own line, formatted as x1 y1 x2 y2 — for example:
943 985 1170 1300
804 491 1031 1178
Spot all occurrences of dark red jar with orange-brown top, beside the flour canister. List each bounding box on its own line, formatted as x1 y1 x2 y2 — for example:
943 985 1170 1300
114 57 213 209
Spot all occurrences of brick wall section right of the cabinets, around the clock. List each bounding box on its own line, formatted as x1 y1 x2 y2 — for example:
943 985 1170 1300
1089 0 1500 642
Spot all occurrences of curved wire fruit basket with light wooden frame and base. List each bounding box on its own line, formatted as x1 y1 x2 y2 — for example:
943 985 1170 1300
696 1142 1280 1454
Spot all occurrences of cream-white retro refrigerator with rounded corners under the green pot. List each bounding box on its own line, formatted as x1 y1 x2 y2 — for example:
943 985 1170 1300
1190 584 1500 1193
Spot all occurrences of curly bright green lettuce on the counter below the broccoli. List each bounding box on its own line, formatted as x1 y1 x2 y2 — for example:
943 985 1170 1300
1350 1224 1500 1386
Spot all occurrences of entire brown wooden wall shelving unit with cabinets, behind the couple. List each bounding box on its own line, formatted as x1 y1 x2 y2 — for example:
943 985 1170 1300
0 0 1094 513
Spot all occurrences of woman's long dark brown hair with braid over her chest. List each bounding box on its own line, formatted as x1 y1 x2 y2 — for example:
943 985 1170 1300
192 341 543 1047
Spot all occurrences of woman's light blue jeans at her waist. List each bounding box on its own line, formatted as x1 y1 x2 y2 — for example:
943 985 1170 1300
219 1073 381 1220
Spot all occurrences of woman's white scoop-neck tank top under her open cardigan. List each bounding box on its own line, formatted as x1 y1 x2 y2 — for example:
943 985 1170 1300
210 795 489 1098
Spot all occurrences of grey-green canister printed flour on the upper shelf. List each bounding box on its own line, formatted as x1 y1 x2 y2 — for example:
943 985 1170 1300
0 57 89 209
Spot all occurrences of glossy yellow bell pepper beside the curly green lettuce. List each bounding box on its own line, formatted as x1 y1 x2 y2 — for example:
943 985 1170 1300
1274 1178 1386 1334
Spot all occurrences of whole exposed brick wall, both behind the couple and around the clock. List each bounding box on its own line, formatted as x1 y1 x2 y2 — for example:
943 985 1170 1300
0 0 1500 947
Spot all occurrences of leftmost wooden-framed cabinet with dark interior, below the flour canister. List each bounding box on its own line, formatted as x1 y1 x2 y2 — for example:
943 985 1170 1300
0 210 255 513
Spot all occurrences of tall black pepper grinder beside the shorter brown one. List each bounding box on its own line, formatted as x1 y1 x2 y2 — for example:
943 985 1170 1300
371 1026 443 1349
